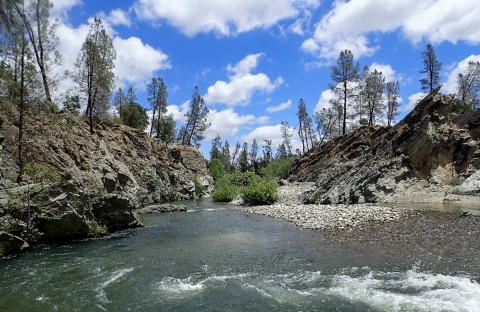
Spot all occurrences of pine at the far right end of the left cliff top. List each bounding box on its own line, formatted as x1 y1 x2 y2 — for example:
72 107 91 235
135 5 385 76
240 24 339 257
182 86 210 147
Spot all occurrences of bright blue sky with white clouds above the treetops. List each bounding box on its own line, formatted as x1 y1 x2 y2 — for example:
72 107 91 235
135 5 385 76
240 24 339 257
47 0 480 158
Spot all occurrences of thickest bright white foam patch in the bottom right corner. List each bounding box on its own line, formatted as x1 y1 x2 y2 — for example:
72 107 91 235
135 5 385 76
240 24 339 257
323 270 480 311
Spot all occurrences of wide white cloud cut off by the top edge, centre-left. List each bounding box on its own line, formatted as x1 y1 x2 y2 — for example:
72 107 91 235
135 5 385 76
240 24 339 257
134 0 320 36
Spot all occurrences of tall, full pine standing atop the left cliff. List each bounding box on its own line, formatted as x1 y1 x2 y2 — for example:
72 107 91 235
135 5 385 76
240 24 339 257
73 18 116 134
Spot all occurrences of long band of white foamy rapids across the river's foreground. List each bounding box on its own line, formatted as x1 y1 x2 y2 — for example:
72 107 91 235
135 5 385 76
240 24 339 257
153 268 480 311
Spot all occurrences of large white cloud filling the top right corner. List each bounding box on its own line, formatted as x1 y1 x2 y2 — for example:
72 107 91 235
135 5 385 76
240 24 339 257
302 0 480 59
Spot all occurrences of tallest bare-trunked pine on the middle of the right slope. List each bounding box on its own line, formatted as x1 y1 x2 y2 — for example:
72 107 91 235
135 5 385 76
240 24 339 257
330 50 360 135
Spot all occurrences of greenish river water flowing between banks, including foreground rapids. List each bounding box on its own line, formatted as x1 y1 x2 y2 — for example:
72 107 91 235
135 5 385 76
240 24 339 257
0 200 480 311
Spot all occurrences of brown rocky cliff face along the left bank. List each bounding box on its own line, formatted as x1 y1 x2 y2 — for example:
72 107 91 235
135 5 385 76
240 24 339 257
0 114 213 254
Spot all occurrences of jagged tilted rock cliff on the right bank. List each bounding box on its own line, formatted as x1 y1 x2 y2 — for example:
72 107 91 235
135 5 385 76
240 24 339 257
290 89 480 203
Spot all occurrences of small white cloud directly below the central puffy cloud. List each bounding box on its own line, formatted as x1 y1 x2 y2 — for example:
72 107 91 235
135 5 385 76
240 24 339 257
204 108 268 139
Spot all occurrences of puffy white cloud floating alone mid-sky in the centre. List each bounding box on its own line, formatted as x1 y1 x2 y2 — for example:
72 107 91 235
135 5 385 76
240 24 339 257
204 53 284 106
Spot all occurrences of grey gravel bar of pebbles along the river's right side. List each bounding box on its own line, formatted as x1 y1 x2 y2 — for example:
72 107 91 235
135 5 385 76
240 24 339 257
243 183 480 262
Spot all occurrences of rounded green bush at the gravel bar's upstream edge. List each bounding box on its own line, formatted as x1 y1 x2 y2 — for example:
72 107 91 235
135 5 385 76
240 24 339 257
240 178 278 205
